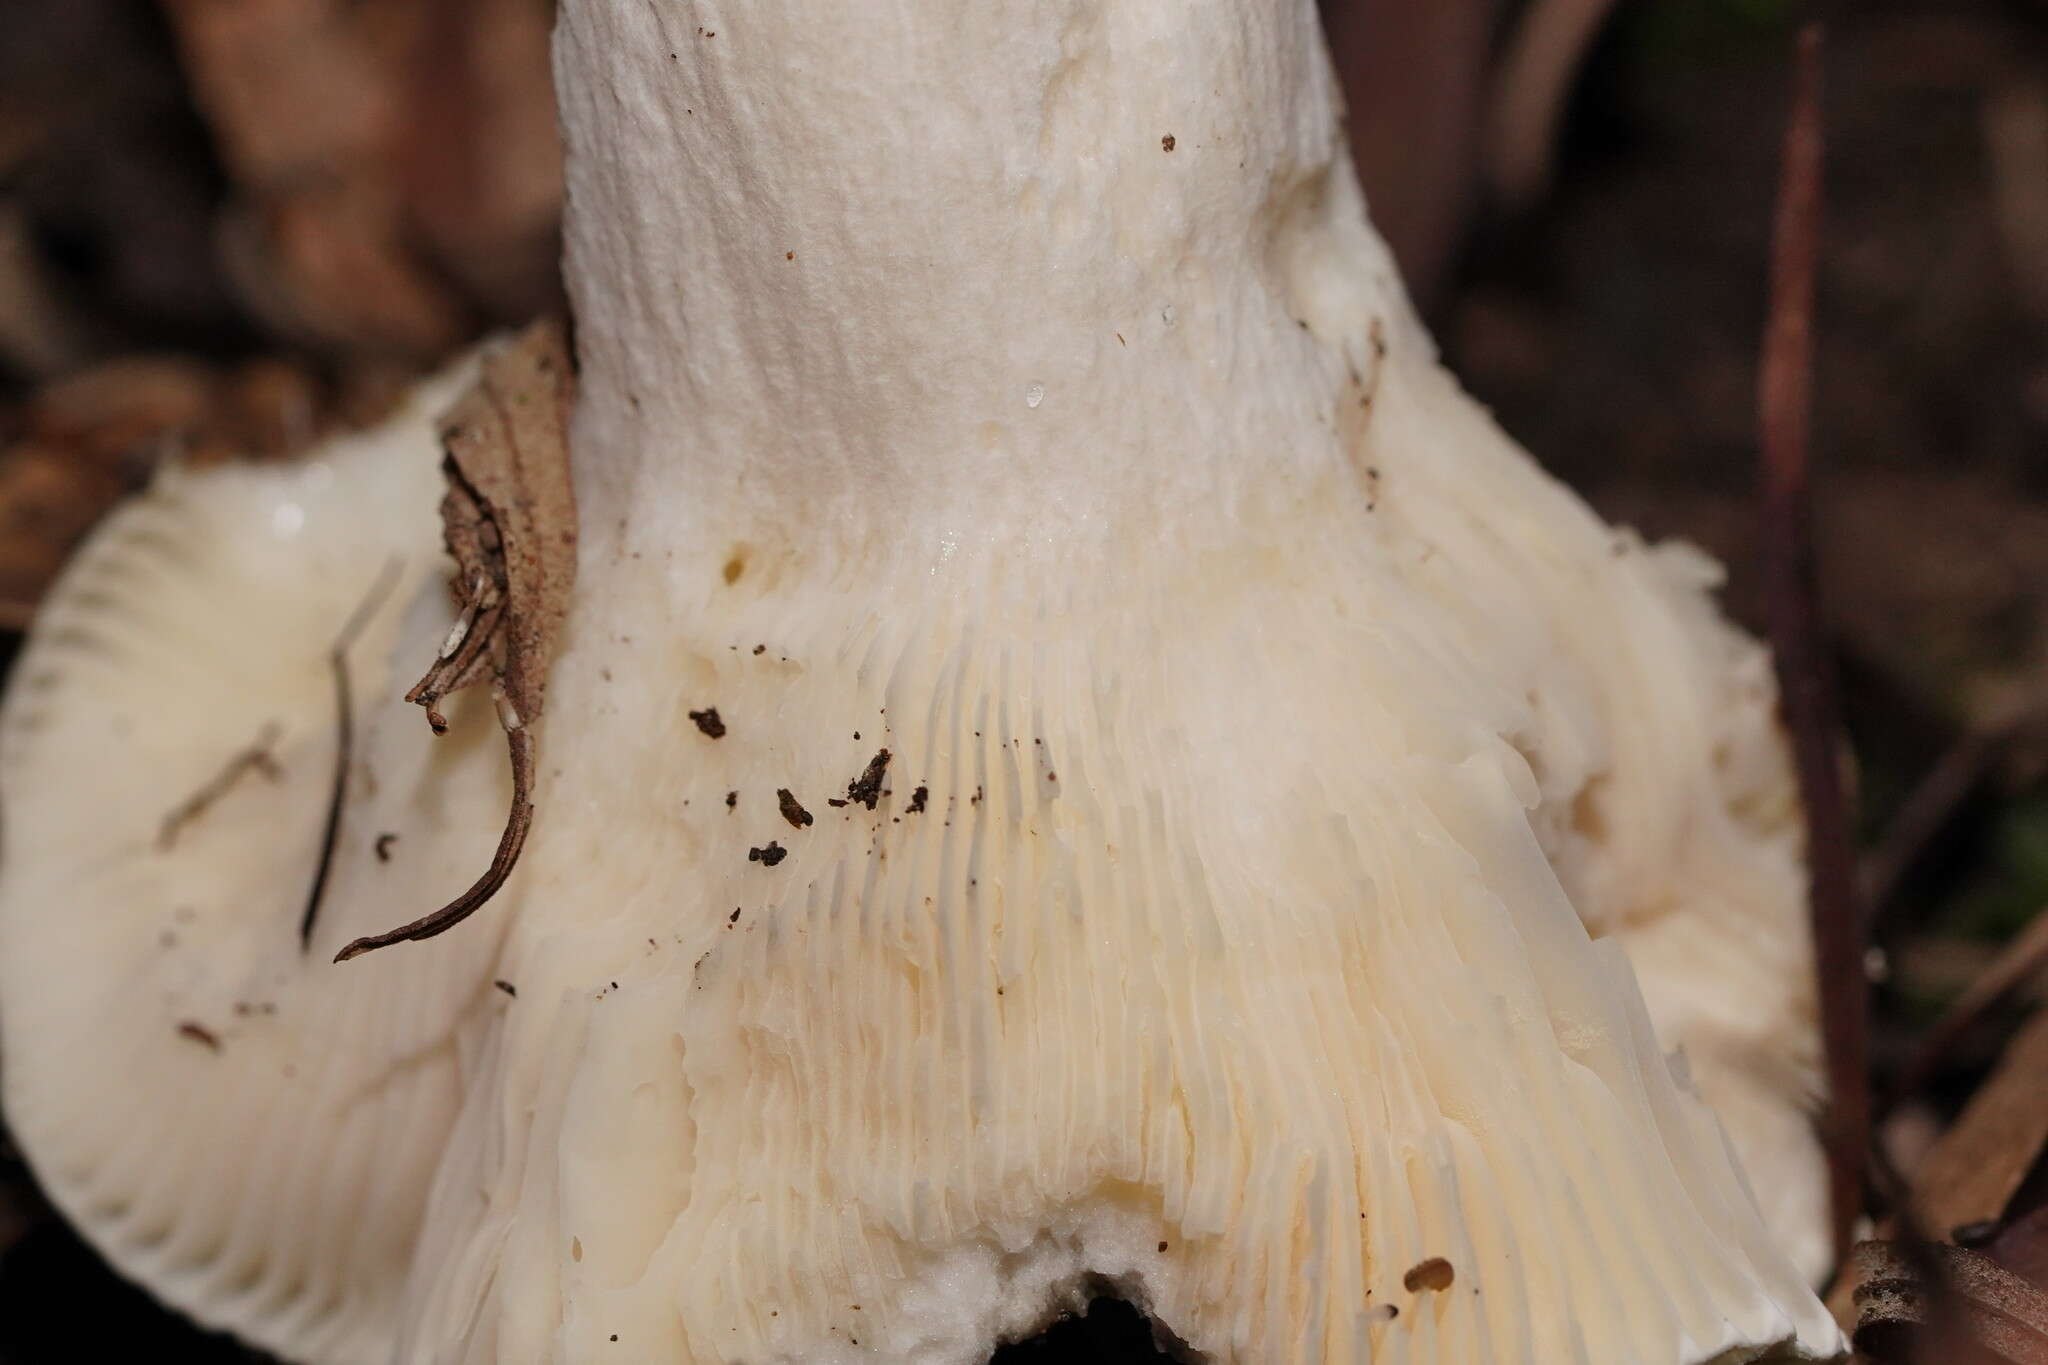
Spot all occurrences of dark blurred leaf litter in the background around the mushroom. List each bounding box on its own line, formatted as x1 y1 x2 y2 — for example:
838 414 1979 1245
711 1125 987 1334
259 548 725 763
0 0 2048 1365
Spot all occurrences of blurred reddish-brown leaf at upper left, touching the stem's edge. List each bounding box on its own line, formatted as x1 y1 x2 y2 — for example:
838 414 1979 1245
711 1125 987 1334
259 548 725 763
164 0 561 358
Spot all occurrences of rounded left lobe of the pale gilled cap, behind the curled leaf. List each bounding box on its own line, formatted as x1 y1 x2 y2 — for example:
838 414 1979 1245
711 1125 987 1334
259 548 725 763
0 366 504 1363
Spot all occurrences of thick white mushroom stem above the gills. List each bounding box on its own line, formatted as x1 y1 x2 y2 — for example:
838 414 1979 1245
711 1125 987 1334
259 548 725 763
557 0 1419 553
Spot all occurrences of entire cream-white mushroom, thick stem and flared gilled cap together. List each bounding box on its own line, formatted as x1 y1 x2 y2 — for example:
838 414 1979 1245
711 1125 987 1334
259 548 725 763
0 0 1843 1365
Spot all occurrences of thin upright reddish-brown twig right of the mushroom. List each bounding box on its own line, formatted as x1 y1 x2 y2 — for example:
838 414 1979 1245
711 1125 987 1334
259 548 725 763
1757 25 1870 1257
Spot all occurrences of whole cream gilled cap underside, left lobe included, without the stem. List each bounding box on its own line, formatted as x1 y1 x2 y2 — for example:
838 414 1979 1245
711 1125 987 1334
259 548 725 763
0 347 1829 1365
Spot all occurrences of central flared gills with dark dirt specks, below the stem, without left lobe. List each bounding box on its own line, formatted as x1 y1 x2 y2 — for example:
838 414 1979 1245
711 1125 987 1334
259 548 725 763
380 381 1839 1365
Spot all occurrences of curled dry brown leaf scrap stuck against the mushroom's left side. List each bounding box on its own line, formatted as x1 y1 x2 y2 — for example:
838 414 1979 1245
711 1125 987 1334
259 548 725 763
334 319 575 962
